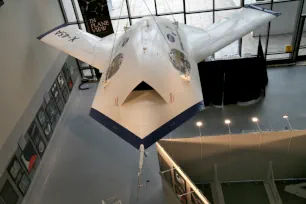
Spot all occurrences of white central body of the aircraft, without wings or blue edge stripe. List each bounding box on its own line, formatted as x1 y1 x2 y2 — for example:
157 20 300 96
92 18 203 139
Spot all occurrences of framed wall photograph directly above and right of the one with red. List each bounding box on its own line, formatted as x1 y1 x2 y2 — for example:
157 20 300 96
28 120 46 156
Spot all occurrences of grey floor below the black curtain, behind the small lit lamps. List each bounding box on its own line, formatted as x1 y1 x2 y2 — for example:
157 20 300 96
167 66 306 138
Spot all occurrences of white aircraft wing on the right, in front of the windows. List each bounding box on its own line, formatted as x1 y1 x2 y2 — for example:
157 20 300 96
180 5 281 62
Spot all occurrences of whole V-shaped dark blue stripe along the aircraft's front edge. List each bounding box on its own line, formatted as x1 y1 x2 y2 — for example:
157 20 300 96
89 101 204 149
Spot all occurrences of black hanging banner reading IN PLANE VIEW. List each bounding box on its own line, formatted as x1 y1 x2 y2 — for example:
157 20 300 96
78 0 114 38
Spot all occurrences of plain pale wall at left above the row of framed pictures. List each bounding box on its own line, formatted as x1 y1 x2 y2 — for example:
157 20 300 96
0 0 65 150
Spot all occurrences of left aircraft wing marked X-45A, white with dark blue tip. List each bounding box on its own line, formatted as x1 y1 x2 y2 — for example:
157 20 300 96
38 24 122 72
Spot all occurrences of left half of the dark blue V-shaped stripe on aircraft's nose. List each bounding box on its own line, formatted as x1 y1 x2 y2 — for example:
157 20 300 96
89 108 142 149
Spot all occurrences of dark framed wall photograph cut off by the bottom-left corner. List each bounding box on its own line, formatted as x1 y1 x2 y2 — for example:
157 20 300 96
0 180 19 204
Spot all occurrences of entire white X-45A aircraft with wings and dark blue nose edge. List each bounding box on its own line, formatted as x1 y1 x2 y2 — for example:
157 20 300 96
38 5 280 149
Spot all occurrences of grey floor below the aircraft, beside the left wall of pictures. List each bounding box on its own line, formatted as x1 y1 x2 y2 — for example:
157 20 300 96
23 83 177 204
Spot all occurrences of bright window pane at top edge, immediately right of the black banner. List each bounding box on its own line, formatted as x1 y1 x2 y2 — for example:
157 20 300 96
107 0 128 18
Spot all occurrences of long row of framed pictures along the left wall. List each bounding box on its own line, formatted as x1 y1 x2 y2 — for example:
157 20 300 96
0 59 79 204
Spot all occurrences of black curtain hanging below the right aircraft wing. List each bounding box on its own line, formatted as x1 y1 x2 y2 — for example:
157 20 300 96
198 39 268 106
